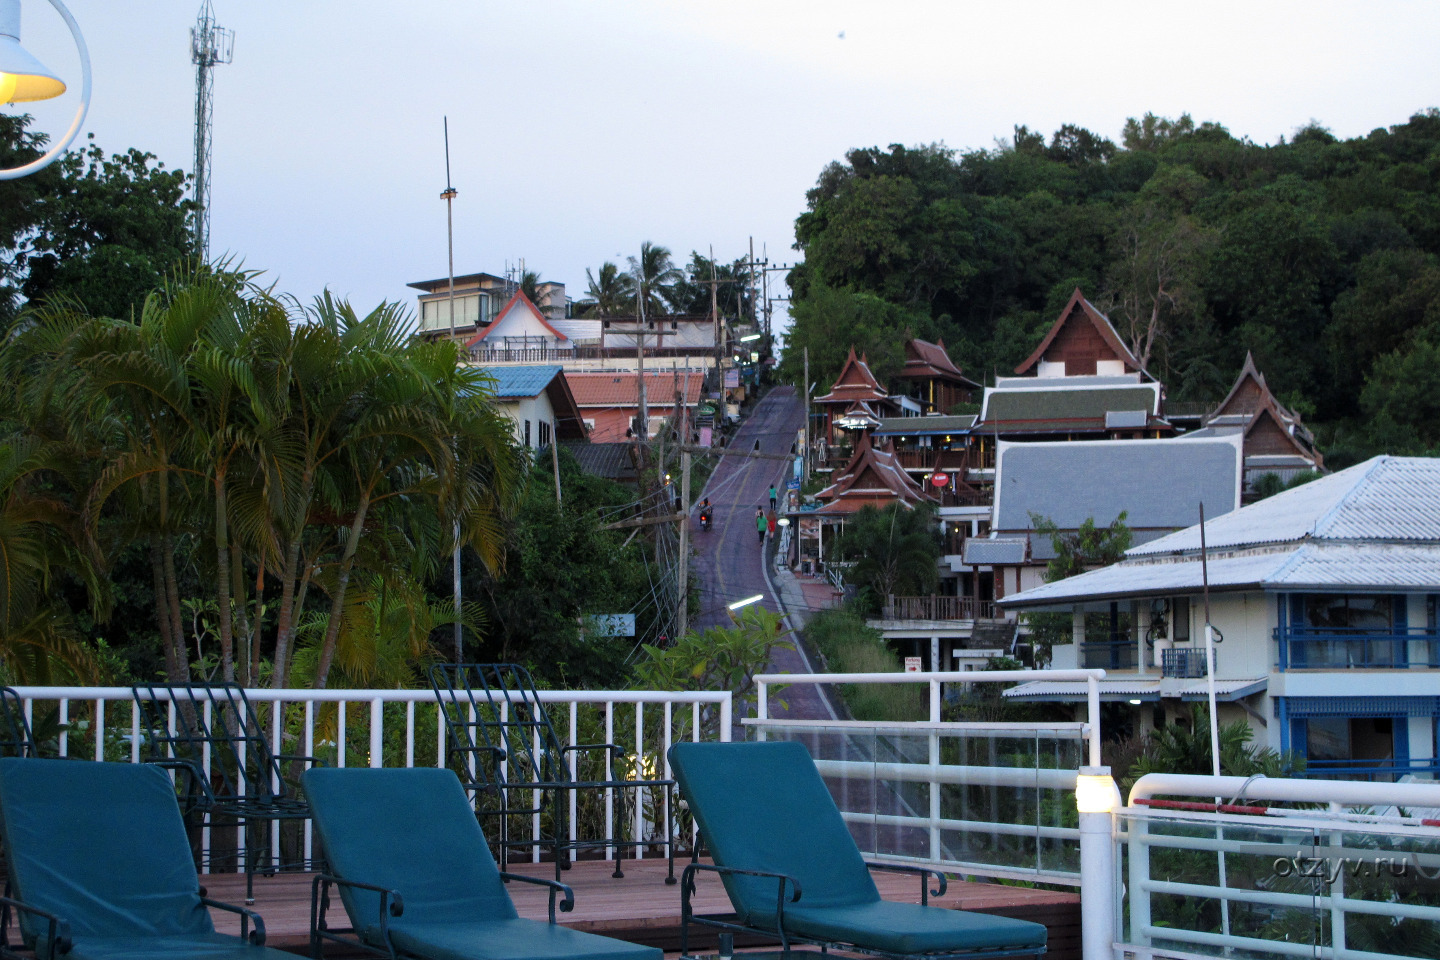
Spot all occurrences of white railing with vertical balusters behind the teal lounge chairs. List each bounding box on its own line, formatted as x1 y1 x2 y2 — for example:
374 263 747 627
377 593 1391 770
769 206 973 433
14 687 733 880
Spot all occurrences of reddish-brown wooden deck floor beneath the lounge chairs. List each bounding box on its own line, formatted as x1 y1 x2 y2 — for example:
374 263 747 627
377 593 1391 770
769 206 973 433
200 859 1080 960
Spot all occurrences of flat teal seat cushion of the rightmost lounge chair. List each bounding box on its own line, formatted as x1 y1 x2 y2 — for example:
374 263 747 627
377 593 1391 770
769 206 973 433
785 897 1047 953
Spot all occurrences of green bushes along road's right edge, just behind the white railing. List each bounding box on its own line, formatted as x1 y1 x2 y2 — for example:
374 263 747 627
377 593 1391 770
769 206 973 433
805 607 926 723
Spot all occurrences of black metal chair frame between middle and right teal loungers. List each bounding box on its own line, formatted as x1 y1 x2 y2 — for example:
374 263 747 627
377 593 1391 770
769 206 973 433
431 664 675 884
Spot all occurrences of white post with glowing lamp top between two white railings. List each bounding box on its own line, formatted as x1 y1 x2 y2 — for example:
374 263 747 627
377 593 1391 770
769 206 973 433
1076 766 1120 960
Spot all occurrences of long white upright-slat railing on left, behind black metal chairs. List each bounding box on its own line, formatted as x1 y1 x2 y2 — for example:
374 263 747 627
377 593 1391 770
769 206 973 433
16 687 733 880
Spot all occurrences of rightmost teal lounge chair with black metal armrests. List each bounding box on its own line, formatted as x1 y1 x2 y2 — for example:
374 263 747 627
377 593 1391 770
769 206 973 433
670 743 1047 960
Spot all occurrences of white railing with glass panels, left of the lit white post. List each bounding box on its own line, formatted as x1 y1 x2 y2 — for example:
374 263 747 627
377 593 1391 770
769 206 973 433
742 669 1104 885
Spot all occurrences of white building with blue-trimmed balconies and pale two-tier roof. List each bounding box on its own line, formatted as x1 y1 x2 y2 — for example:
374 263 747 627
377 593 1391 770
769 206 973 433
1002 456 1440 779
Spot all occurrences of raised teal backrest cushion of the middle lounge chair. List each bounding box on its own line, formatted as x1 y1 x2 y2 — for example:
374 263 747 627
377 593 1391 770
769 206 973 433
304 767 518 941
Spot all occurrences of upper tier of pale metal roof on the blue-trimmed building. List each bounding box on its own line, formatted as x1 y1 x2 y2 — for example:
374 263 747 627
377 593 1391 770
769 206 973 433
1130 456 1440 556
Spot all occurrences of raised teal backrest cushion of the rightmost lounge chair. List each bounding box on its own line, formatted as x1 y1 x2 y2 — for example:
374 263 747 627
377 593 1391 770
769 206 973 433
670 741 880 925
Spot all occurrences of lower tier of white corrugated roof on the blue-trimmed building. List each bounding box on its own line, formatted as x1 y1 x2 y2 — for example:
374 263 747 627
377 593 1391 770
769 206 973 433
1001 543 1440 609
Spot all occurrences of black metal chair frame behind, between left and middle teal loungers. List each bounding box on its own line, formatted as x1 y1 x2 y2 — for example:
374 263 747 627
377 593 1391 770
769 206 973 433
131 682 317 904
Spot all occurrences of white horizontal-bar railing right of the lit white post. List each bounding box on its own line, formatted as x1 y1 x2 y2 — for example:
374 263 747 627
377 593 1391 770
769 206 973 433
1113 774 1440 960
